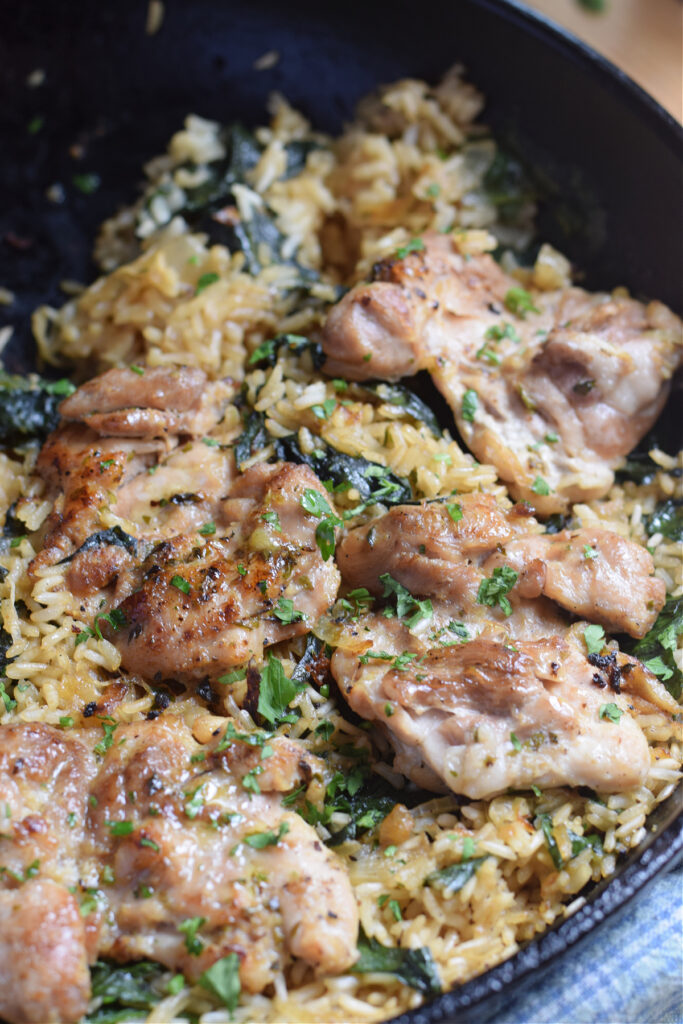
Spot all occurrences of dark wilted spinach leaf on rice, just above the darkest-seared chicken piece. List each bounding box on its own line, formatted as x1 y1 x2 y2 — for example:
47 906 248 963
274 434 413 505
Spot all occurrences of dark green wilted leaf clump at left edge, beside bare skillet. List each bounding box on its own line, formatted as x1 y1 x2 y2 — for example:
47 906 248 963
0 373 75 444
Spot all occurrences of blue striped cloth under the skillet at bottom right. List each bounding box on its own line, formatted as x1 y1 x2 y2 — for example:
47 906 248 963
490 867 683 1024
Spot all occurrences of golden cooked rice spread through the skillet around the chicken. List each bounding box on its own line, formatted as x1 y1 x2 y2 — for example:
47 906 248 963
0 68 683 1022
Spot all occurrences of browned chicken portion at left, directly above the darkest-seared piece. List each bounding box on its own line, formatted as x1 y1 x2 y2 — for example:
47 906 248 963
30 368 234 577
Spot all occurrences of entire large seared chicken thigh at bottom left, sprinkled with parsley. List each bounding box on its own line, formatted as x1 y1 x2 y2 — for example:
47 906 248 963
0 718 357 1024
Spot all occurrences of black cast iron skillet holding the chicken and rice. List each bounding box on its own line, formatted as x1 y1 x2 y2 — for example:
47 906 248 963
0 0 683 1024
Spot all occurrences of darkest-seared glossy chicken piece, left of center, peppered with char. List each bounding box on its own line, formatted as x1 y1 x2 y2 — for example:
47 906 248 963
112 463 339 682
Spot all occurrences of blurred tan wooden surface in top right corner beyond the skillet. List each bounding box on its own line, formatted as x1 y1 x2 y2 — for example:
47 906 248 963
523 0 683 121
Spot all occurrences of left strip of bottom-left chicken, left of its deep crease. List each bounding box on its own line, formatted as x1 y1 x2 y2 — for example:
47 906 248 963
0 723 95 1024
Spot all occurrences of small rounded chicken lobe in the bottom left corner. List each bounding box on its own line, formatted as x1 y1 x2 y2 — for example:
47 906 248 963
0 879 90 1024
